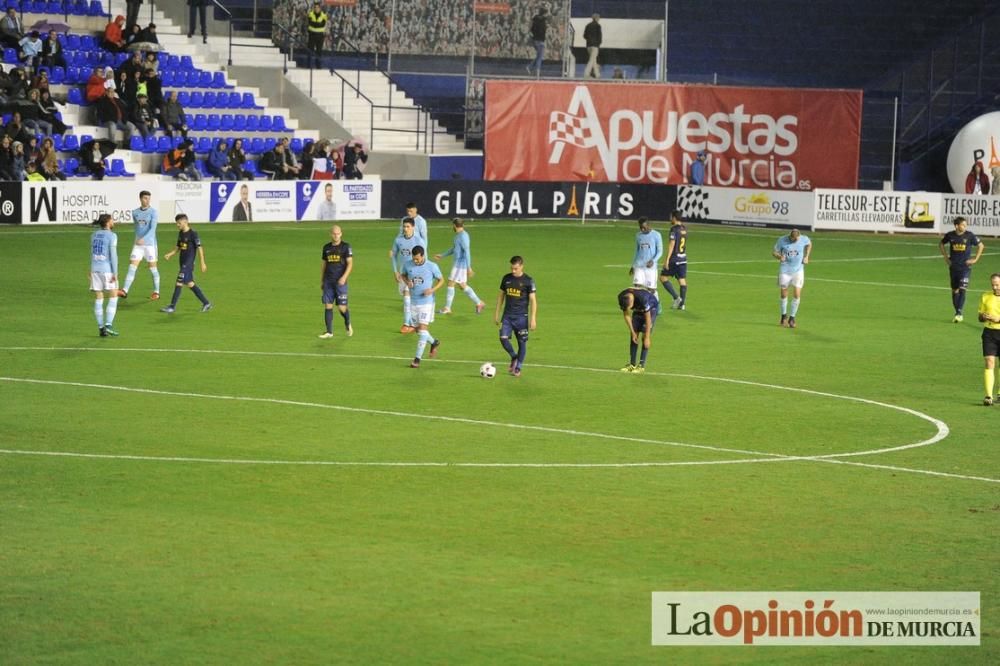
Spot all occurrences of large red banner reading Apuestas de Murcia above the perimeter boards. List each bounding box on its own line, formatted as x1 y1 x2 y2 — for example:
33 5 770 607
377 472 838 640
485 81 861 190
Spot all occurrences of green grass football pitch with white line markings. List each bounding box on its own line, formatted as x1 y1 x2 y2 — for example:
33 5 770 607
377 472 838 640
0 220 1000 664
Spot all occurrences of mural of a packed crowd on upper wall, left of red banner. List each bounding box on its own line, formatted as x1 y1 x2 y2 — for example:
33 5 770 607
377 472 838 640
274 0 569 60
